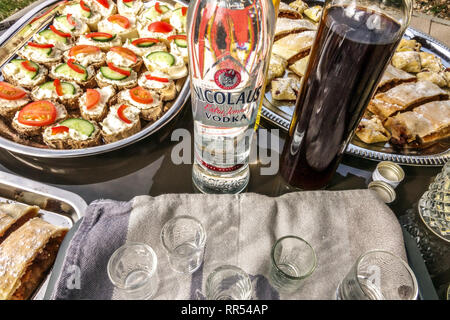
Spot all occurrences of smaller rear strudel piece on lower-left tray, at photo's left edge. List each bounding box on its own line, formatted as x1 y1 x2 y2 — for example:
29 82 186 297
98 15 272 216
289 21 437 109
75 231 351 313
0 203 39 244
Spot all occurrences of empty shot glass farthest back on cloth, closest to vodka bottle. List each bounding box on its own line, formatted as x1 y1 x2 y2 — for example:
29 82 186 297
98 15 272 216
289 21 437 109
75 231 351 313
161 216 206 273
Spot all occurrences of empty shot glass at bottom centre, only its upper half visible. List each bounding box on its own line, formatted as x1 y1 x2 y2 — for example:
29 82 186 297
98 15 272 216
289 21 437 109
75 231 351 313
205 265 252 300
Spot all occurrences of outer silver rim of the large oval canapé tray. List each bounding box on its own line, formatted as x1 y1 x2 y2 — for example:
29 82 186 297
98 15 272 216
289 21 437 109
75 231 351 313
0 0 190 158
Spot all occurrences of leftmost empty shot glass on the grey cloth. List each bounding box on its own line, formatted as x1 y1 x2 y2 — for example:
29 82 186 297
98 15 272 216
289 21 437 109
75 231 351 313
107 243 159 300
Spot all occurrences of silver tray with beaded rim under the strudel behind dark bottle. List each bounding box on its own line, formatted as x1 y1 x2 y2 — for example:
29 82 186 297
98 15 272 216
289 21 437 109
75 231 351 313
261 1 450 166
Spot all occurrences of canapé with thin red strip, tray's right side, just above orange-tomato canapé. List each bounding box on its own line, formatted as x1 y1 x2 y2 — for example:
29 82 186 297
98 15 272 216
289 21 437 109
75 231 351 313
138 71 177 101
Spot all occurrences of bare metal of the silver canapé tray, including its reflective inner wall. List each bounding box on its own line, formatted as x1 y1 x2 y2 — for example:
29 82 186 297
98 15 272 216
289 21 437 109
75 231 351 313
0 0 189 158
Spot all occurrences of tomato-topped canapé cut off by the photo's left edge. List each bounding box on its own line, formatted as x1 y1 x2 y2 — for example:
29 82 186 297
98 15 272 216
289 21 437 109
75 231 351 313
0 81 30 119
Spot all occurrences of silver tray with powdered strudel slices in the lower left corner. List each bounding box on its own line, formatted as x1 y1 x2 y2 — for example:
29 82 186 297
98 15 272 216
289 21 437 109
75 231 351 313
0 172 87 300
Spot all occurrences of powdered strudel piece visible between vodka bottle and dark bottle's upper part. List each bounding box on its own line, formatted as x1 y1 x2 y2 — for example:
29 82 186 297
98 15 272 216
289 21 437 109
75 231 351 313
272 31 316 64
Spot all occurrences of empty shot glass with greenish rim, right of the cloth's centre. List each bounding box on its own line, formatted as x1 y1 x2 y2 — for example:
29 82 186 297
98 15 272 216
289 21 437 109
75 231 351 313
269 235 317 293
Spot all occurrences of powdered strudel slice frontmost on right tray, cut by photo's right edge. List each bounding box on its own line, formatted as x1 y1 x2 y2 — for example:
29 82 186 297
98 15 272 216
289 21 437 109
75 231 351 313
385 100 450 145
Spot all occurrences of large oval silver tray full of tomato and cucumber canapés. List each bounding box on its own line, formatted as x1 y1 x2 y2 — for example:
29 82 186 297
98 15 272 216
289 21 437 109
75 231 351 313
0 0 189 158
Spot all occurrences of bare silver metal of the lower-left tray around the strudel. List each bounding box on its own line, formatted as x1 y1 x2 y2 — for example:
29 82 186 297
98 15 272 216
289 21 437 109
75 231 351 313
0 171 87 300
